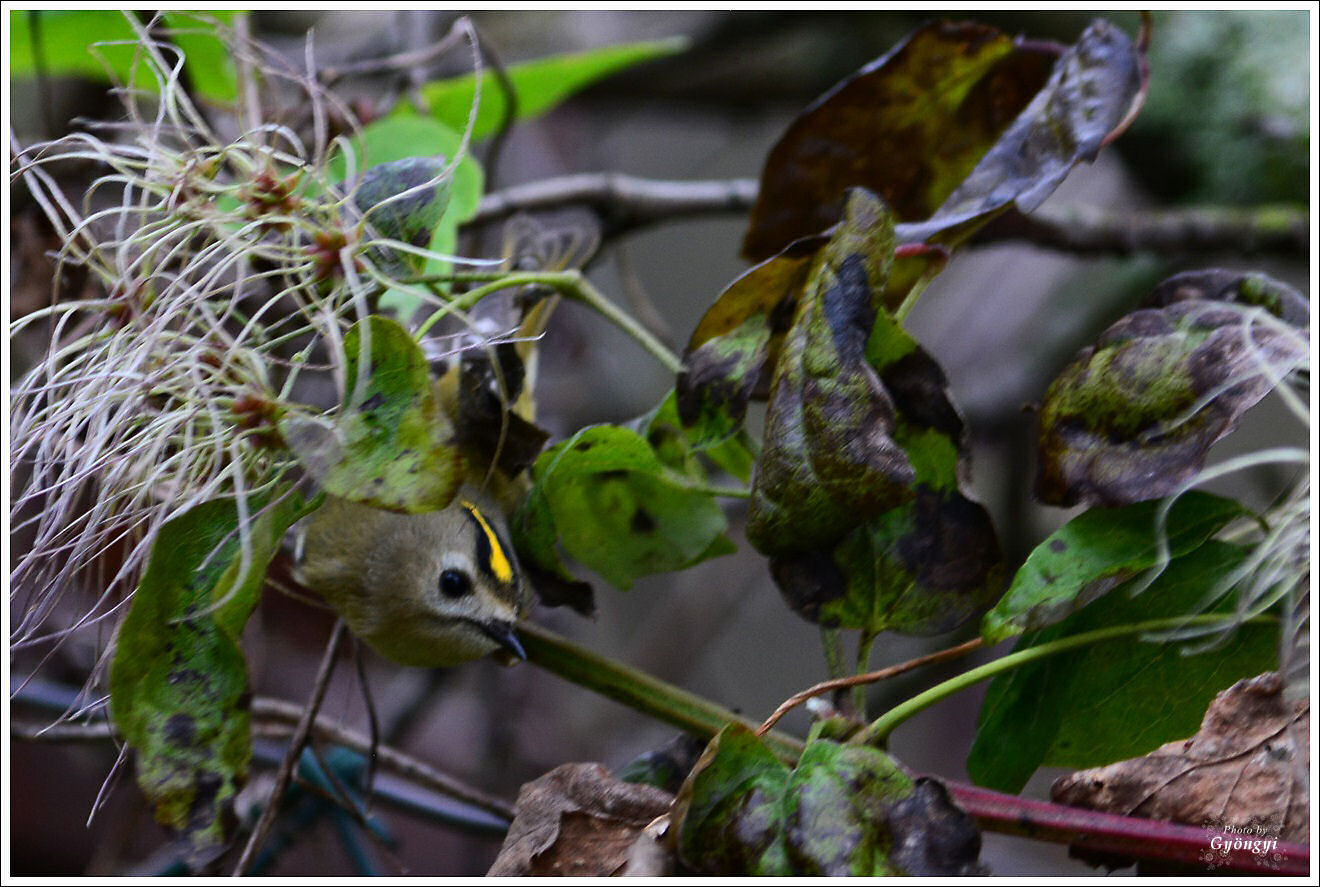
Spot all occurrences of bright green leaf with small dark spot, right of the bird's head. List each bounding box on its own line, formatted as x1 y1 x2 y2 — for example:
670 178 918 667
513 425 733 589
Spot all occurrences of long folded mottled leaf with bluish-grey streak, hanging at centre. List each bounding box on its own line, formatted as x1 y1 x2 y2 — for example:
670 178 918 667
747 190 915 556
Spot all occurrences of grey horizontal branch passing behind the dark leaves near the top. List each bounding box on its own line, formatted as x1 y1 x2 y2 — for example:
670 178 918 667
469 173 1311 256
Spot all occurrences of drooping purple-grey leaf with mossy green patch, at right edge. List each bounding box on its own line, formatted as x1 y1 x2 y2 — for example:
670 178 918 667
1036 290 1309 506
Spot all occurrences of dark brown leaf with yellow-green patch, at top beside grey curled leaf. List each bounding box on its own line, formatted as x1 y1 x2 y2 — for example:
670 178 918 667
743 21 1056 261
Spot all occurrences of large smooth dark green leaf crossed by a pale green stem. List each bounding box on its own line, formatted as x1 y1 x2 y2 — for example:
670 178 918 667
968 540 1278 792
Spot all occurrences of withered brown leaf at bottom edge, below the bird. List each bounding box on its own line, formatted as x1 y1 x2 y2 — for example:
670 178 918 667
486 763 673 878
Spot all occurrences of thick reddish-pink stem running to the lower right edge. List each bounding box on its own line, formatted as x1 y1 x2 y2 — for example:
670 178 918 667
941 780 1311 875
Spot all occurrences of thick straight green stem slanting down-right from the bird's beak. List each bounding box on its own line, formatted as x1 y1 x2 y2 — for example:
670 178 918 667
517 623 803 763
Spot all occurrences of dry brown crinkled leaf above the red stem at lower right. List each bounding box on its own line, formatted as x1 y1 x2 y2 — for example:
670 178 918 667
1051 672 1311 843
